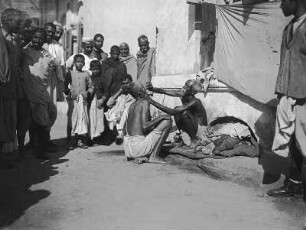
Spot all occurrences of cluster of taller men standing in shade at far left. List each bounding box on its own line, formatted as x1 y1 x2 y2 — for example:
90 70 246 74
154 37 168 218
0 9 65 159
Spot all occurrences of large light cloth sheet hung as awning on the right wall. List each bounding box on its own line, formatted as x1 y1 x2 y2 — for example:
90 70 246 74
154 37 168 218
214 2 290 103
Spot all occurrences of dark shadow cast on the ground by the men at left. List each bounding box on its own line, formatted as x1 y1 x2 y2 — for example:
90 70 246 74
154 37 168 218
0 139 68 228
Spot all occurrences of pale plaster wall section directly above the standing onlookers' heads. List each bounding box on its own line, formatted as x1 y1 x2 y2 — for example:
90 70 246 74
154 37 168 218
80 0 157 54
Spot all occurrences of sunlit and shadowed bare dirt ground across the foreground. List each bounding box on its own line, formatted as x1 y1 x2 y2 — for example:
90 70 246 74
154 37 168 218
0 117 306 230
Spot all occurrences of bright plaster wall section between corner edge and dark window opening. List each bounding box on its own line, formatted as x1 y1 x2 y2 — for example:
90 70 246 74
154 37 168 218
156 0 201 75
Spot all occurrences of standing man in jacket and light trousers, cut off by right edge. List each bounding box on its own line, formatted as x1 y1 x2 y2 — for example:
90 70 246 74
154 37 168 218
268 0 306 202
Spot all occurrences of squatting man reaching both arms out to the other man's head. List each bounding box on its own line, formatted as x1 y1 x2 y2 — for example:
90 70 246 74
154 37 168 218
147 80 207 147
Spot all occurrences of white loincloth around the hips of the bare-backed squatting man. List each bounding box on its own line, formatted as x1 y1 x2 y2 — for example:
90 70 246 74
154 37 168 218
123 130 162 158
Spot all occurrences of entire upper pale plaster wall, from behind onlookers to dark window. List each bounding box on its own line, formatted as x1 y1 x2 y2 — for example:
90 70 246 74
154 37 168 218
74 0 200 75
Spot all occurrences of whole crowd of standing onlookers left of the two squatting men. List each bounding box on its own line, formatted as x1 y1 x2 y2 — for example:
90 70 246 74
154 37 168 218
0 9 155 160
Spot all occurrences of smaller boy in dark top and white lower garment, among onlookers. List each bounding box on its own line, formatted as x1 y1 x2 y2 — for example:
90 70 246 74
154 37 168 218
89 60 104 140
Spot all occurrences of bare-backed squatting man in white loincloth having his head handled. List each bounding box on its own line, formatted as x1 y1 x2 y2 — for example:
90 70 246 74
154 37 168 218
123 83 172 163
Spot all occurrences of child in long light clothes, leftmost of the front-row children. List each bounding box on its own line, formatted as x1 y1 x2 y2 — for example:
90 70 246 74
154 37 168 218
64 54 94 149
